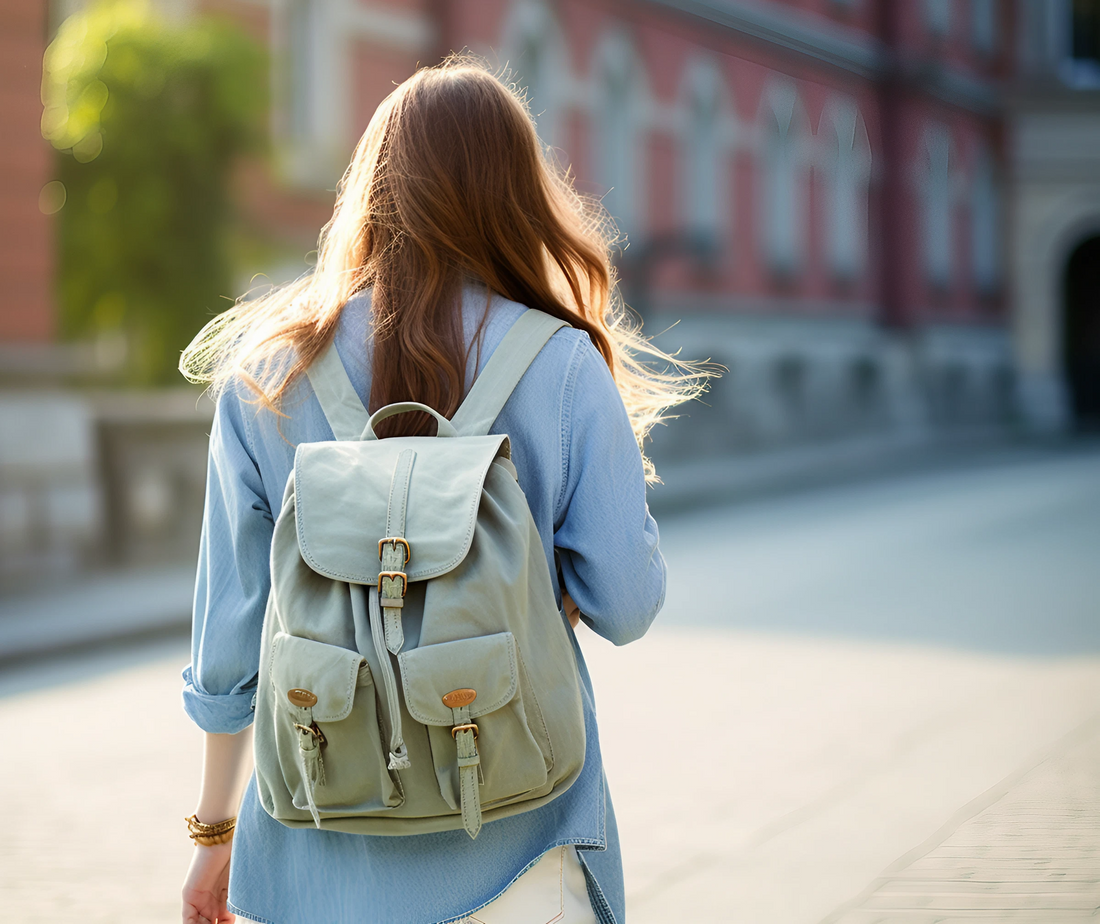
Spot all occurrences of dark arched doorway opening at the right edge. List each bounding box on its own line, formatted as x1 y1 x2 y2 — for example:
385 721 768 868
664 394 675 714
1063 234 1100 429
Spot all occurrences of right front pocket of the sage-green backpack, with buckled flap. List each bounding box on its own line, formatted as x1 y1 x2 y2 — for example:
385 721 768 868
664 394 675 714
398 633 548 813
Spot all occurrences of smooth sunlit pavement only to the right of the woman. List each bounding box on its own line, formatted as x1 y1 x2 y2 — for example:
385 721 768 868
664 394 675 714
586 630 1100 924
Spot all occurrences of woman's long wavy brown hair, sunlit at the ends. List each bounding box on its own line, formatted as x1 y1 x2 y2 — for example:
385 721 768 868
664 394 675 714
179 57 708 480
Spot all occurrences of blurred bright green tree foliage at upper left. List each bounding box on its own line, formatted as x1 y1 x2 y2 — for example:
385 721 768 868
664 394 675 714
42 0 266 385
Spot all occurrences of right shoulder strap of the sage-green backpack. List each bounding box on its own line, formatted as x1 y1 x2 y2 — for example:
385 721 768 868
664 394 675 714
451 308 569 437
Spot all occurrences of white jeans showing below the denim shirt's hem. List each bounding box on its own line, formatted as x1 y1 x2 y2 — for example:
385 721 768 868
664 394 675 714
466 844 596 924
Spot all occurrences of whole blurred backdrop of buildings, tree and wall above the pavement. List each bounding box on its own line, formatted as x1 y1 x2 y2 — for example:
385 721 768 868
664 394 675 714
0 0 1100 591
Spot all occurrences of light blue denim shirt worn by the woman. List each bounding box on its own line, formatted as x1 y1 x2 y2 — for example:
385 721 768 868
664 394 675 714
184 288 664 924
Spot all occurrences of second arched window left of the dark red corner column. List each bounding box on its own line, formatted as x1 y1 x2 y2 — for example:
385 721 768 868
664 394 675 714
759 81 807 275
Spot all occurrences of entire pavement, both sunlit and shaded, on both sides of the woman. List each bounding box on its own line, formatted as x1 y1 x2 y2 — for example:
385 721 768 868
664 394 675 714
0 446 1100 924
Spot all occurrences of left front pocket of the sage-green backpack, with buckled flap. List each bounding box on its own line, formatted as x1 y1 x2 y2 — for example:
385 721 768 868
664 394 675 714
271 633 403 824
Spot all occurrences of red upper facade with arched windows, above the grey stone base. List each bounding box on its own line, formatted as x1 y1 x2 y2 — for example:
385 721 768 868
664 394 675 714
201 0 1012 326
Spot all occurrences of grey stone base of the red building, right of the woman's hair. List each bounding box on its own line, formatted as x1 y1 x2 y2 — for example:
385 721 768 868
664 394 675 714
647 315 1016 463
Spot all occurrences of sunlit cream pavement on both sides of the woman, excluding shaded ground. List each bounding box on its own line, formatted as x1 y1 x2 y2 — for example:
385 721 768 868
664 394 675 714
0 629 1100 924
